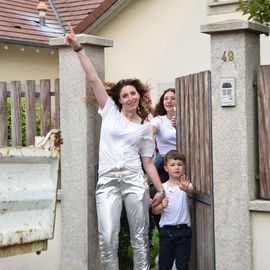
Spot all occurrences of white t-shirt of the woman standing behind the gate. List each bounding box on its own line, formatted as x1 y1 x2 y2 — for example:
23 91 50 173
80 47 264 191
150 115 176 155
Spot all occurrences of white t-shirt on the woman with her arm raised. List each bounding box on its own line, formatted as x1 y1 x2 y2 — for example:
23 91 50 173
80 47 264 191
98 97 155 175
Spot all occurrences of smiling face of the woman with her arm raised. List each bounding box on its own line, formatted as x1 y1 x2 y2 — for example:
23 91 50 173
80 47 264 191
119 85 140 111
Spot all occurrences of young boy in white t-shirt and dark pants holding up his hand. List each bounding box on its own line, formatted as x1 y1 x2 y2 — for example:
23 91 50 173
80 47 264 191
152 150 194 270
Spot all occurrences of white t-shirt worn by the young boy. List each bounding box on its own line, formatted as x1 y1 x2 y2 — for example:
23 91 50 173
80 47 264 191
159 181 192 227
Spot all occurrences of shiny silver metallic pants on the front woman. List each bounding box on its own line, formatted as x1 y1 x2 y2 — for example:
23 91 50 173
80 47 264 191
96 170 150 270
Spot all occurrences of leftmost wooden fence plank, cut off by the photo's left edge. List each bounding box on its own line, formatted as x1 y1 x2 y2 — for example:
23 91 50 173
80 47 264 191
0 82 8 146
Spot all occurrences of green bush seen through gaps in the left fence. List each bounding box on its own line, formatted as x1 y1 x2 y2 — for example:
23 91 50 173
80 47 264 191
7 97 40 146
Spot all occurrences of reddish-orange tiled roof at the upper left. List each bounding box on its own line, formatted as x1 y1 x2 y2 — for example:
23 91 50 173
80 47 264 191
0 0 117 47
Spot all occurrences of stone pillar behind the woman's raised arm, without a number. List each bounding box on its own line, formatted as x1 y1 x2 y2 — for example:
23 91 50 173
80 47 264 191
50 34 113 270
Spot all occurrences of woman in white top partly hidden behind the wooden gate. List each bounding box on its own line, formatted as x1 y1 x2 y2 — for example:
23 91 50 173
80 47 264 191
150 88 176 229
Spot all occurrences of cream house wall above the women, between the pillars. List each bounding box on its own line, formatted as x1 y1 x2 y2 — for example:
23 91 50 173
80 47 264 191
95 0 270 101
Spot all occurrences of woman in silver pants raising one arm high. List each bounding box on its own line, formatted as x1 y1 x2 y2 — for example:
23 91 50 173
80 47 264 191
65 25 164 270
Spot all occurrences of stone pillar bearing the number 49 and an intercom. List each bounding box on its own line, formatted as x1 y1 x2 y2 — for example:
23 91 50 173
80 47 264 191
201 20 269 270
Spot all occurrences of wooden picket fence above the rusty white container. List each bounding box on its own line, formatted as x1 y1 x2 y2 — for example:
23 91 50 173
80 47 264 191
0 79 60 147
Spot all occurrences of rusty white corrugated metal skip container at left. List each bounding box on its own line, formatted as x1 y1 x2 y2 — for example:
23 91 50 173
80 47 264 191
0 132 60 257
